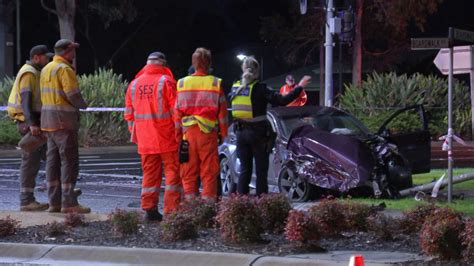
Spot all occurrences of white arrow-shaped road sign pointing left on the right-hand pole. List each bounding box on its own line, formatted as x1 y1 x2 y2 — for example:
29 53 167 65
434 46 474 75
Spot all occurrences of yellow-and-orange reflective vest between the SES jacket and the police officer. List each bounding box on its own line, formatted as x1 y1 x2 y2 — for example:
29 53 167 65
176 75 221 133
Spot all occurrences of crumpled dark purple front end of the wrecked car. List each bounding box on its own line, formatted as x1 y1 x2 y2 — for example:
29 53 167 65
285 123 411 197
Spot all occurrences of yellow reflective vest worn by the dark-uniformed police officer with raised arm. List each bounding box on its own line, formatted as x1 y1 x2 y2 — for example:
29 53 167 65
231 80 257 120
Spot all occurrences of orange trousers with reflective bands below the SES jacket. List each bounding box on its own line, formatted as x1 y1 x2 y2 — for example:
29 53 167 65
141 151 182 214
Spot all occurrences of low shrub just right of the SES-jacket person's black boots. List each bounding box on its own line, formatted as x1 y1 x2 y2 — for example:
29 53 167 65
161 210 197 241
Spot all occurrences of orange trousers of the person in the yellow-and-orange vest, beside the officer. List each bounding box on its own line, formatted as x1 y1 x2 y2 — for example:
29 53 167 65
181 125 219 201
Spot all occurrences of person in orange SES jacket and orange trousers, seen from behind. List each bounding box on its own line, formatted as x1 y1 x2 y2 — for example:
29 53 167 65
124 52 182 221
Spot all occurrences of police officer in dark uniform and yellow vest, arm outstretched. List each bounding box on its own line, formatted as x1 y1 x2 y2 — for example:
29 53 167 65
230 56 311 195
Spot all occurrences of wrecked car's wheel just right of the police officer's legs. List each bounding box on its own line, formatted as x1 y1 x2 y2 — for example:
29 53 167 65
278 167 313 202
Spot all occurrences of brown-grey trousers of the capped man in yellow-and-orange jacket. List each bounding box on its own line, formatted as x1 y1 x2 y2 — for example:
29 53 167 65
46 129 79 208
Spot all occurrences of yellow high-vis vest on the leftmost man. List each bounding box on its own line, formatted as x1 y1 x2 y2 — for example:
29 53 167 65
7 64 41 122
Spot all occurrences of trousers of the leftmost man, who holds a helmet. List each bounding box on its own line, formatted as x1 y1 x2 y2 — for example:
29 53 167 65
17 122 46 206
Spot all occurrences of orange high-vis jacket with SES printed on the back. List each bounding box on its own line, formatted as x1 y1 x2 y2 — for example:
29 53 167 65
124 64 178 154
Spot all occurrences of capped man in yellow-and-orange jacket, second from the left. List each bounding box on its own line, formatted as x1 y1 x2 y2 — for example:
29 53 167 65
40 39 91 213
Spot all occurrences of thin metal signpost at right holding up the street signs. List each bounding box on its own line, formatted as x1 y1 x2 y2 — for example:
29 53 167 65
447 27 454 203
